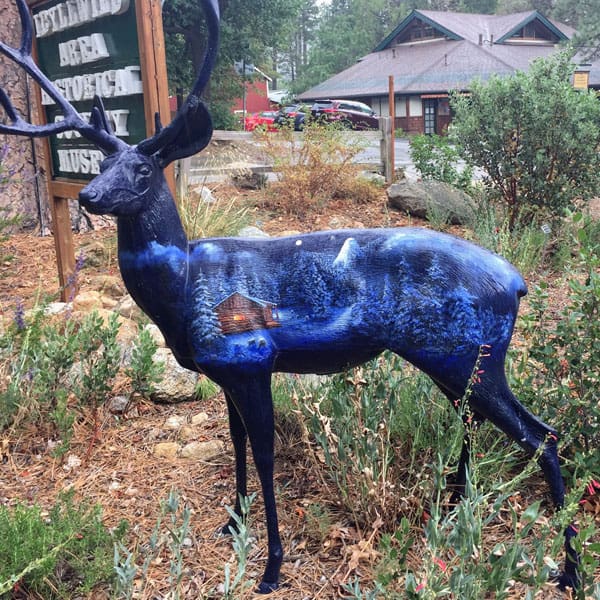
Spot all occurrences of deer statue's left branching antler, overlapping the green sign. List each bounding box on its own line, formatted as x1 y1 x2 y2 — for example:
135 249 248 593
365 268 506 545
0 0 127 154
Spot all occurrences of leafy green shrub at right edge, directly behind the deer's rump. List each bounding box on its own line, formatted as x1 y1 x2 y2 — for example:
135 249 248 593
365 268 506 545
518 215 600 474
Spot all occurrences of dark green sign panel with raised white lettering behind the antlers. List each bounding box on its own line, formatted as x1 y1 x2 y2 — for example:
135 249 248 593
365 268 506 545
33 0 146 180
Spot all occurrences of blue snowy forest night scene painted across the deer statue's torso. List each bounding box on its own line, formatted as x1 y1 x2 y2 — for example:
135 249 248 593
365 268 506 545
120 228 525 382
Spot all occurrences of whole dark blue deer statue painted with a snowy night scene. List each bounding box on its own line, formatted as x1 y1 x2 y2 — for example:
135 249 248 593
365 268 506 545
0 0 579 593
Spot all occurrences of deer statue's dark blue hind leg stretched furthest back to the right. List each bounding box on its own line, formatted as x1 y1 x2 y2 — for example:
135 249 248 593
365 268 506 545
470 372 580 589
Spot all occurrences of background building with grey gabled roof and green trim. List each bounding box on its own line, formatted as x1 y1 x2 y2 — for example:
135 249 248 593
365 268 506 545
299 10 600 133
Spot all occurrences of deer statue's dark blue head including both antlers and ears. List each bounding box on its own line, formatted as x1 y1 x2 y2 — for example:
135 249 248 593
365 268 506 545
0 0 219 216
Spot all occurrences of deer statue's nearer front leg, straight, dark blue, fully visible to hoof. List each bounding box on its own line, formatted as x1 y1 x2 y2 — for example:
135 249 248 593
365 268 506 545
227 372 283 594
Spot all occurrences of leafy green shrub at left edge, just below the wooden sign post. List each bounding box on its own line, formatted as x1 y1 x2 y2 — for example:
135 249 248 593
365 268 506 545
0 305 121 455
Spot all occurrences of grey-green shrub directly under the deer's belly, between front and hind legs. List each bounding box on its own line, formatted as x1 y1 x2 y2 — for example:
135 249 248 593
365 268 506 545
294 354 453 529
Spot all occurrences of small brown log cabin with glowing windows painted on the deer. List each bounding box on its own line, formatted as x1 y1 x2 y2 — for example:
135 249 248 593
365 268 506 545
214 292 280 335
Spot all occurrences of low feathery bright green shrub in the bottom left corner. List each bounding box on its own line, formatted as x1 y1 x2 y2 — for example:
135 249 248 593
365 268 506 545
0 490 126 600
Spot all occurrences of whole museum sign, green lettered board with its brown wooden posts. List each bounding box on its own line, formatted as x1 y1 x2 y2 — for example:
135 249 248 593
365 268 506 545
30 0 175 301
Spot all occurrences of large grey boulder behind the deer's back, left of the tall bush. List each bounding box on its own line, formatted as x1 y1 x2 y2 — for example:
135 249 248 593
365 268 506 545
387 180 475 225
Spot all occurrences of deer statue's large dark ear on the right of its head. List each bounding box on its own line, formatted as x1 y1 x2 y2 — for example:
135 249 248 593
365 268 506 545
138 96 213 167
